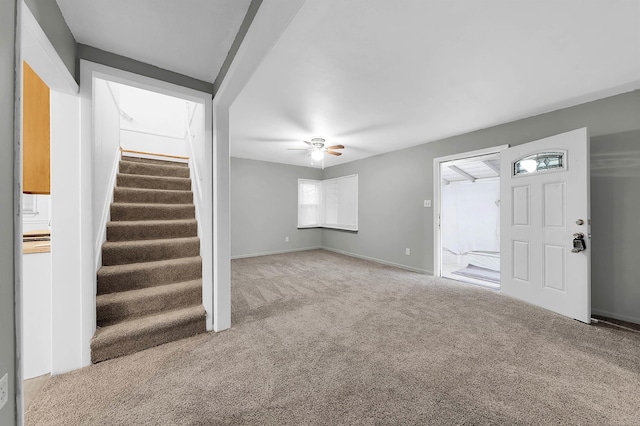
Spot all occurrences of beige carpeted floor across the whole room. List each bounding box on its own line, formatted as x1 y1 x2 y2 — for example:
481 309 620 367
26 250 640 425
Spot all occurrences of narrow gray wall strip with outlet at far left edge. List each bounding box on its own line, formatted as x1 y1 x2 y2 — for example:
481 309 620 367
0 0 17 425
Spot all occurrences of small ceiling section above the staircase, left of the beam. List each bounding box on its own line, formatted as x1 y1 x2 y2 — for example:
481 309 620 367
57 0 251 83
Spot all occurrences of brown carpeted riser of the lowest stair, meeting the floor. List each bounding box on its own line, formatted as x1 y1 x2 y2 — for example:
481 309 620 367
91 318 206 363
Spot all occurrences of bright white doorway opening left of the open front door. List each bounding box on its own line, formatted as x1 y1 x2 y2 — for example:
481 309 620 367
434 147 508 290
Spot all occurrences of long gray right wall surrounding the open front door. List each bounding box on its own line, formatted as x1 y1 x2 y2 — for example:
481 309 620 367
322 91 640 322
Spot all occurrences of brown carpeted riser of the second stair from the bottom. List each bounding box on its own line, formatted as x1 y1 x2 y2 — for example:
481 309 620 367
96 287 202 327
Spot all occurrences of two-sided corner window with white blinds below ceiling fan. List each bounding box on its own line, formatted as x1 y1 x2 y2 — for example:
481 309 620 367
298 175 358 231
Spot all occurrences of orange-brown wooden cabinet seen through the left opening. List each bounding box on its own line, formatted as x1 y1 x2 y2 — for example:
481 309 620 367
22 62 51 194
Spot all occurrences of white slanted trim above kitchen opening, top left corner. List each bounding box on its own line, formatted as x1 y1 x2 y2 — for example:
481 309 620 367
19 0 79 94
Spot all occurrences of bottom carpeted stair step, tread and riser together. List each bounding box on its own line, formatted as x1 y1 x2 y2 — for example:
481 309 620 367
91 305 206 363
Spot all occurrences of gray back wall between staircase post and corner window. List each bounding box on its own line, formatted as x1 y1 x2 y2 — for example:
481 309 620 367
231 157 322 257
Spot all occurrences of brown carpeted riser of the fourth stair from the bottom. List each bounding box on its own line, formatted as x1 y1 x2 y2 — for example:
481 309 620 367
102 239 200 266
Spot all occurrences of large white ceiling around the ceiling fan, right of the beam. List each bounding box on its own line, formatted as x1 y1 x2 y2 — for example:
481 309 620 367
230 0 640 167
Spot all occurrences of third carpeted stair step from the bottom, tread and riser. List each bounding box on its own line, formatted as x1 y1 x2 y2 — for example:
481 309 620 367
98 256 202 294
